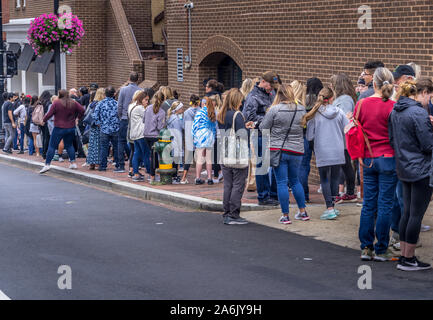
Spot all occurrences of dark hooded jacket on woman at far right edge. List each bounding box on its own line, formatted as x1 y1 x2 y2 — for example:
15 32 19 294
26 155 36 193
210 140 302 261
388 97 433 182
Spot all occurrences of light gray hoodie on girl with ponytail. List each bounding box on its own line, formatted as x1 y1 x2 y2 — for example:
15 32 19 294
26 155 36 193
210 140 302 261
307 105 349 168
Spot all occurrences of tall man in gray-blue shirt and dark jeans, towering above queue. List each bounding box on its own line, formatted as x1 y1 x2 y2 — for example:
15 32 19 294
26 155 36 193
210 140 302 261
114 72 141 173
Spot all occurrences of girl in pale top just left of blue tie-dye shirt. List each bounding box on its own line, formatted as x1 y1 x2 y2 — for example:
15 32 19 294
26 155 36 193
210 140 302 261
180 94 201 184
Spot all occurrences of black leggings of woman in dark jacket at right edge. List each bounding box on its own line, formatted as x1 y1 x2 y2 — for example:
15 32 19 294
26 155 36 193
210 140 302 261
399 177 433 244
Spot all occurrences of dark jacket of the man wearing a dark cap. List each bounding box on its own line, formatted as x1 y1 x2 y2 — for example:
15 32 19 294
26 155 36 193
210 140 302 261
242 83 275 128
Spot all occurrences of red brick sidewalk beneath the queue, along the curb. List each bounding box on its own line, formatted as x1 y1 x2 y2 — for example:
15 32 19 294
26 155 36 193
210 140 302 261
7 151 338 204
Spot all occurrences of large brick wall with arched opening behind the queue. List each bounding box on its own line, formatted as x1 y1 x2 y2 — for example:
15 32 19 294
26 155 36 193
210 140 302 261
165 0 433 183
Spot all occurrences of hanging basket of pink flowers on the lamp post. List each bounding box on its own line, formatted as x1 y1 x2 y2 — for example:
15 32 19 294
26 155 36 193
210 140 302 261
27 13 84 56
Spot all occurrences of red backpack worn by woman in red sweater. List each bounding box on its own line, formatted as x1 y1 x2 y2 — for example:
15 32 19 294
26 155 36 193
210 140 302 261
344 99 373 168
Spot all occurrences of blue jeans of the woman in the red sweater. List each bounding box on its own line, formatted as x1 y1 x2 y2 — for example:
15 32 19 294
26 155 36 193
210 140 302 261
359 157 397 254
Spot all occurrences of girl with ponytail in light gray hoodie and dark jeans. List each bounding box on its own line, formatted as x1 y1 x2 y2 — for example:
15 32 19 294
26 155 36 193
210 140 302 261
303 87 349 220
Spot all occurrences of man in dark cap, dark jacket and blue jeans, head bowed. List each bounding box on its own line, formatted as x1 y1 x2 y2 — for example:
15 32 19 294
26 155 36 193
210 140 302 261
242 71 279 206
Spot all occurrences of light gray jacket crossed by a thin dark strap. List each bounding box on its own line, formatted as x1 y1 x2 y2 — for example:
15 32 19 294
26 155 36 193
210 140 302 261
260 103 306 154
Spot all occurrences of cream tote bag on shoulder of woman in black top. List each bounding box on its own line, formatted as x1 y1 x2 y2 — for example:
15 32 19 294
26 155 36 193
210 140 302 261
222 111 249 169
